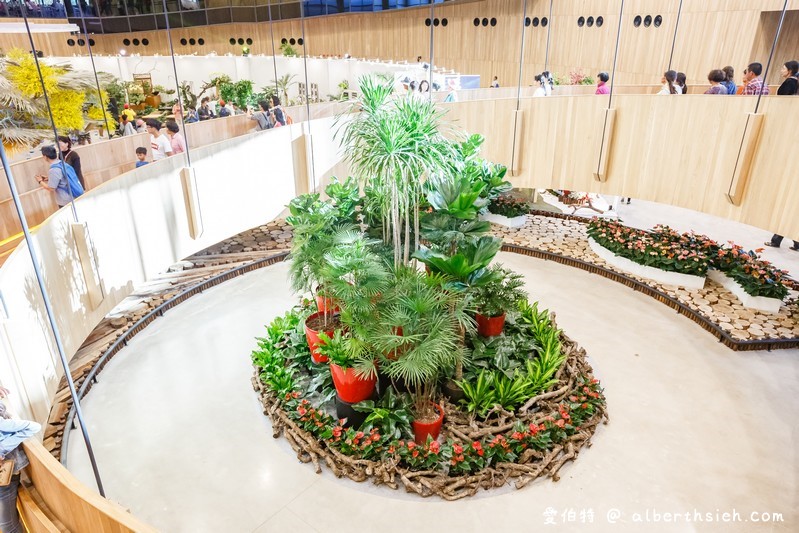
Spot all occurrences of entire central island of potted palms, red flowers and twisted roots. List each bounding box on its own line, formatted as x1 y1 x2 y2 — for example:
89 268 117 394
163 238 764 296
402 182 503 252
252 78 605 499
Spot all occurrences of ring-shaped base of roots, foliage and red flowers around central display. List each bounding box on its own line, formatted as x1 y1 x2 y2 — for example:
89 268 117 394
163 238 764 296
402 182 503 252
252 307 605 500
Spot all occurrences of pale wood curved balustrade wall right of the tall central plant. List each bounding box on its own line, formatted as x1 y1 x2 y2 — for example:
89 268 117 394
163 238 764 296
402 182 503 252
448 94 799 237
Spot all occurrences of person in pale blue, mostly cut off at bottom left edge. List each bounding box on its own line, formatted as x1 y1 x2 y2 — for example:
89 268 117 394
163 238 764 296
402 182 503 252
0 387 42 533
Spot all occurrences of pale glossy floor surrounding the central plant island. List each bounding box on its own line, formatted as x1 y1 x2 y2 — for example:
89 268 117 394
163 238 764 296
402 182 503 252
68 252 799 533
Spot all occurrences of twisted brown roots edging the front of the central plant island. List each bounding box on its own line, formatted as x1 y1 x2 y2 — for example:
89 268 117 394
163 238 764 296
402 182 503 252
252 324 608 501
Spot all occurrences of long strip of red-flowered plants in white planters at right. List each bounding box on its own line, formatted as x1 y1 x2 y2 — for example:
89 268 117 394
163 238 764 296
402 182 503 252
588 218 788 308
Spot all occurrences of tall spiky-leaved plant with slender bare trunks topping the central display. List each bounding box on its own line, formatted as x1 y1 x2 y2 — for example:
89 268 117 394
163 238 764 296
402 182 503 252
336 77 455 265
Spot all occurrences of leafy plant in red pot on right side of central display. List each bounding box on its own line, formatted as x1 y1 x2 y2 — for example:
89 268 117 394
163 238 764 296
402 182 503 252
472 265 527 337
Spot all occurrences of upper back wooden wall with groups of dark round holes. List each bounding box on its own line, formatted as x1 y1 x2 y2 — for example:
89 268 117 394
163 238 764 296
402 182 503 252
0 0 799 86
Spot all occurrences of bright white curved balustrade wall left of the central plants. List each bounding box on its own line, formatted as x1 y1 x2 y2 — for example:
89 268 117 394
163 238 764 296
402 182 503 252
0 118 346 421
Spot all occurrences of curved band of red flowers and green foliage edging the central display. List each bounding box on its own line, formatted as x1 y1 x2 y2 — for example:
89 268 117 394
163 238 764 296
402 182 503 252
253 309 605 476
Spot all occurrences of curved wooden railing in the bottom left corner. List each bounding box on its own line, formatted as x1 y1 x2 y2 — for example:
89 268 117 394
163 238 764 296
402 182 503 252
17 440 156 533
